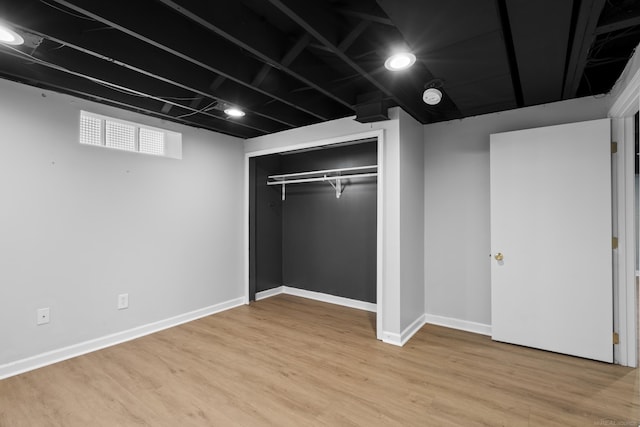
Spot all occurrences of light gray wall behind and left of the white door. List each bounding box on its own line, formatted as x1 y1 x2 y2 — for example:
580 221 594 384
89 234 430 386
424 96 610 325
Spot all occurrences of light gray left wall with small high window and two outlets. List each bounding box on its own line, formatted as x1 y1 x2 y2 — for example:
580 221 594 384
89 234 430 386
0 80 244 366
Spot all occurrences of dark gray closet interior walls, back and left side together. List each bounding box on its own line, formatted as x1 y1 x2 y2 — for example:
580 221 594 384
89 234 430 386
249 142 377 303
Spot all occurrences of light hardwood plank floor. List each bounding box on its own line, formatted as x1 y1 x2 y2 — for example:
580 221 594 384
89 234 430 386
0 295 640 427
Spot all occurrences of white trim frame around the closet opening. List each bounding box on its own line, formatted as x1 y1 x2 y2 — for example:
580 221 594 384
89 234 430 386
244 129 384 340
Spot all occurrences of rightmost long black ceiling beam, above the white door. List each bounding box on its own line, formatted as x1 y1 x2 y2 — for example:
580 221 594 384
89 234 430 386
562 0 607 99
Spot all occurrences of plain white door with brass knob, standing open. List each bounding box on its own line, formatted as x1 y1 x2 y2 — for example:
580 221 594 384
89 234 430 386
491 119 613 362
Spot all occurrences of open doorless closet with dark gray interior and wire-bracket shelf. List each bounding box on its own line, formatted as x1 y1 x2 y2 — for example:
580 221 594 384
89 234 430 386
246 132 382 338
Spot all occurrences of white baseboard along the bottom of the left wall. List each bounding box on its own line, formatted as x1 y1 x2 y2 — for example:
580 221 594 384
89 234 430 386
0 297 245 380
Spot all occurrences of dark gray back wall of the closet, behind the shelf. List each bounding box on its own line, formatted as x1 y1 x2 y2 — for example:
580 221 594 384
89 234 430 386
281 142 377 303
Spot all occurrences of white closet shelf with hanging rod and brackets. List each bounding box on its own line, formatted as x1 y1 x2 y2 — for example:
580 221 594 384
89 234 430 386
267 165 378 200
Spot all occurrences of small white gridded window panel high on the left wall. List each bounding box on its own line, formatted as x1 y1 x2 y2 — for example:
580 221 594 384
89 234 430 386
80 111 182 159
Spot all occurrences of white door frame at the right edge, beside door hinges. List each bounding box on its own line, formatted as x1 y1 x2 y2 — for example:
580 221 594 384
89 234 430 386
609 69 640 368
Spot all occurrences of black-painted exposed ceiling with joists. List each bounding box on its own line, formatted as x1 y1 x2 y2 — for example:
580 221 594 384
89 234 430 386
0 0 640 138
